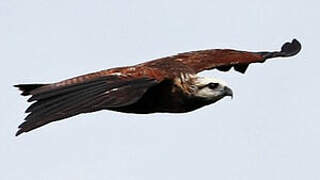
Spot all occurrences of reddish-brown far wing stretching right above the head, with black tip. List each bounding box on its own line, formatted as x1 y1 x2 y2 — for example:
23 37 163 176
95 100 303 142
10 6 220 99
149 39 301 73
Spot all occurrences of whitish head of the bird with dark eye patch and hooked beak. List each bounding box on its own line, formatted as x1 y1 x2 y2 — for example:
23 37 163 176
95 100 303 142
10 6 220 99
193 77 233 103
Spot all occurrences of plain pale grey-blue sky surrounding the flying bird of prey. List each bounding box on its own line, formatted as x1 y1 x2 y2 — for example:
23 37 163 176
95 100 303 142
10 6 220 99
0 0 320 180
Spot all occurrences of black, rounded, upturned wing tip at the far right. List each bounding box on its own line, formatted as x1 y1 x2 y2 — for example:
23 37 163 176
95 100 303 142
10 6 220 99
258 39 301 60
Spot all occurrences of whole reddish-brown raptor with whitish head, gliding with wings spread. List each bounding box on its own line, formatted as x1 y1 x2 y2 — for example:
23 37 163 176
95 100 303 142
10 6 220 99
15 39 301 136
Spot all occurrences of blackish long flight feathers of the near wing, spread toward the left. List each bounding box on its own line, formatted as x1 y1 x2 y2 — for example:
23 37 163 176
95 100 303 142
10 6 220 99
15 76 158 136
